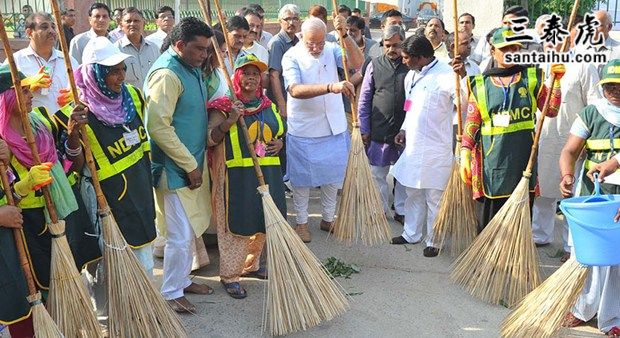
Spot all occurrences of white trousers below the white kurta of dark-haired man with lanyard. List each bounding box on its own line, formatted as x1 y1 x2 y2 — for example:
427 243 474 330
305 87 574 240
402 187 443 247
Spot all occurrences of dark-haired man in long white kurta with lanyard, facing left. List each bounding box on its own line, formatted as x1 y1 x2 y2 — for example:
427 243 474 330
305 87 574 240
391 36 465 257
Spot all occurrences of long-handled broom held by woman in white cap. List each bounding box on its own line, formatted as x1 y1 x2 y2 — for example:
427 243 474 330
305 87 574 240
51 0 187 337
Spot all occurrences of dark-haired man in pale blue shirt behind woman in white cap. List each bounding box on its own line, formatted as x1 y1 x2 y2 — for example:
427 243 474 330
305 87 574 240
115 7 160 90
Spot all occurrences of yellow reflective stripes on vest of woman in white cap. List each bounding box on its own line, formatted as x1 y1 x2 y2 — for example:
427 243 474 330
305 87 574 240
60 85 150 181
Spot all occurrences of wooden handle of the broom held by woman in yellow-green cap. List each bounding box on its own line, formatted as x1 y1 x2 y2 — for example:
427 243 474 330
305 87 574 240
203 0 266 186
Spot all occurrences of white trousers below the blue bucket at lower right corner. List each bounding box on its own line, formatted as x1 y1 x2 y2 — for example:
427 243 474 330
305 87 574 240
573 264 620 332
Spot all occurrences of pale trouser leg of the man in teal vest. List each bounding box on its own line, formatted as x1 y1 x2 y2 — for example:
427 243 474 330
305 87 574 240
161 193 195 300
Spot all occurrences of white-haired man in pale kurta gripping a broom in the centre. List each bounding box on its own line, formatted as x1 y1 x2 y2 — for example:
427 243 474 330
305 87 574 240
282 15 364 243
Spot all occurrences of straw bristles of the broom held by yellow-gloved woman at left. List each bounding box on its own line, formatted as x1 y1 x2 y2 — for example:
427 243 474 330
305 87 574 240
47 220 103 337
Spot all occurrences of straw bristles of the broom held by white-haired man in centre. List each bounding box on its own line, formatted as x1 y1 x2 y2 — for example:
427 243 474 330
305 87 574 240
334 126 392 245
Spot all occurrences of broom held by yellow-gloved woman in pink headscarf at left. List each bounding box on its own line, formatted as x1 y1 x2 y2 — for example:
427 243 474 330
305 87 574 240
0 11 102 337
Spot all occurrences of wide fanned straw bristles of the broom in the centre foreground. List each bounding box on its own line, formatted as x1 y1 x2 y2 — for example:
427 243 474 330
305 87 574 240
258 185 349 336
